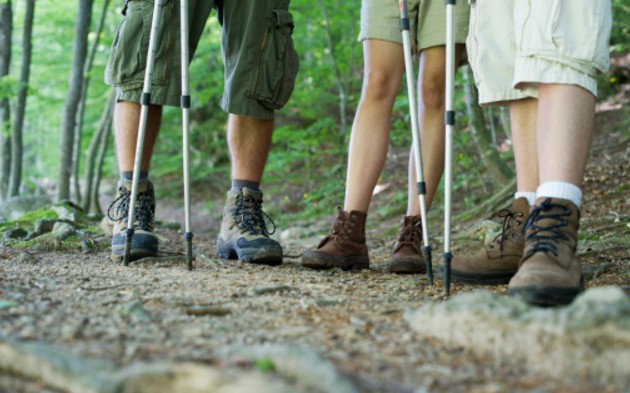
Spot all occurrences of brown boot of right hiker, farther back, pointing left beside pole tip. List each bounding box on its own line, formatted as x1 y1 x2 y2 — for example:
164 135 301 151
451 198 529 285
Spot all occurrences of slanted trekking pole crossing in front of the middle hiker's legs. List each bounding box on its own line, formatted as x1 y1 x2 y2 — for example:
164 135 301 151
398 0 433 285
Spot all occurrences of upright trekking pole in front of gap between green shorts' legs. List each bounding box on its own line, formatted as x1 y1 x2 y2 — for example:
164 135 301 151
180 0 193 270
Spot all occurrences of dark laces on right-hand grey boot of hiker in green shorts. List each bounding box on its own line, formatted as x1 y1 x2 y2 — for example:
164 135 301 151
230 195 276 237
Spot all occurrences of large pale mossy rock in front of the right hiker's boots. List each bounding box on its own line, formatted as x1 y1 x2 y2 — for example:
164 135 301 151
405 287 630 389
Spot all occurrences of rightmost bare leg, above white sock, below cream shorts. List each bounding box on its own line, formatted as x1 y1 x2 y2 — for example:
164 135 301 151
536 84 595 187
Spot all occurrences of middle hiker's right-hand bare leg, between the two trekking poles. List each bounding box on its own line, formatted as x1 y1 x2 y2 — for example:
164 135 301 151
407 45 464 216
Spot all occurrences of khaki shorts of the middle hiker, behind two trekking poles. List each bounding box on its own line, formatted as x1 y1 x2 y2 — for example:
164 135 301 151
359 0 469 51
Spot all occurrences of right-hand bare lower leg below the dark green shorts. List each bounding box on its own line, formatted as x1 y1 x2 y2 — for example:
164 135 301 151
228 114 273 183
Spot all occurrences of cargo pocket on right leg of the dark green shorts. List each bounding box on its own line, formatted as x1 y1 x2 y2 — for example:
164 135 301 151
248 10 299 110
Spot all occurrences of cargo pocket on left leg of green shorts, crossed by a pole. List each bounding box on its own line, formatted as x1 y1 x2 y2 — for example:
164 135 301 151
105 0 173 90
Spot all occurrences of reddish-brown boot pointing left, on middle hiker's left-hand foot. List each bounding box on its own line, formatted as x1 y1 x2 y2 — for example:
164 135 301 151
302 207 370 270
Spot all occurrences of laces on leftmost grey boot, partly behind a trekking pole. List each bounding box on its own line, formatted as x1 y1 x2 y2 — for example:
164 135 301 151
107 187 154 231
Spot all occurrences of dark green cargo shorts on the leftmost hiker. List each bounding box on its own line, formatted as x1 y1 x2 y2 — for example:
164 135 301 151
105 0 299 119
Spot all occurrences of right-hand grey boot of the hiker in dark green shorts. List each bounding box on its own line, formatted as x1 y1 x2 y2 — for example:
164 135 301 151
217 188 282 265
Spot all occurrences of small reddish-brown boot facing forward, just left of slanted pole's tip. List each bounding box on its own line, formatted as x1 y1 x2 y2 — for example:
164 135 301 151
389 216 427 274
